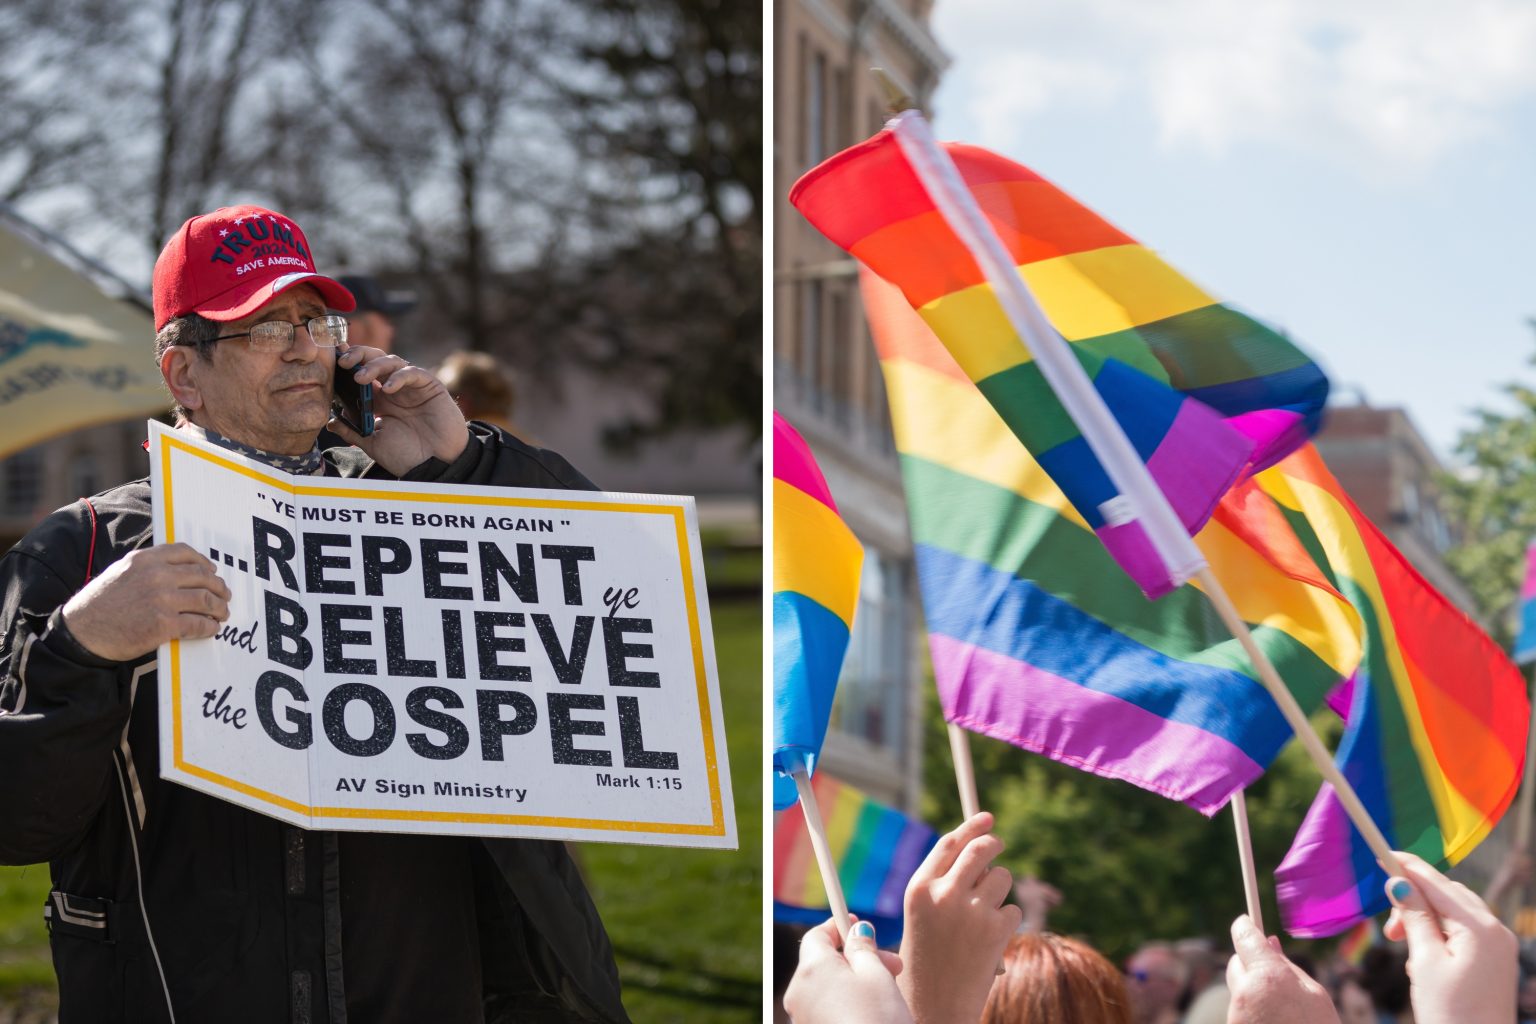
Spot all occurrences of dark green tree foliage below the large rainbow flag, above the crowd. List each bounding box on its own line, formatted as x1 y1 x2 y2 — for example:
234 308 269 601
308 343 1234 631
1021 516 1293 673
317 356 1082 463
923 686 1339 963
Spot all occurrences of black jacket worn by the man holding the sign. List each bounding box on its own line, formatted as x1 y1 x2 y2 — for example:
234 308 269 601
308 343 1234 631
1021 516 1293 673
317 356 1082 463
0 424 627 1024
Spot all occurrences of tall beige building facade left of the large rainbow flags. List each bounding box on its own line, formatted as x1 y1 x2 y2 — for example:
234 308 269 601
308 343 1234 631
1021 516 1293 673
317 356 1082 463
773 0 948 809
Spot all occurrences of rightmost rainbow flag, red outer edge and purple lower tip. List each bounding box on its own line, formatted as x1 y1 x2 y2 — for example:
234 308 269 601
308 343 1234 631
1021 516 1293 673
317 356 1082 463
1252 445 1530 938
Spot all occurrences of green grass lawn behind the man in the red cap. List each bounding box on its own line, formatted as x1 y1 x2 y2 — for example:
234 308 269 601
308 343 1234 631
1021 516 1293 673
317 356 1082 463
0 580 763 1024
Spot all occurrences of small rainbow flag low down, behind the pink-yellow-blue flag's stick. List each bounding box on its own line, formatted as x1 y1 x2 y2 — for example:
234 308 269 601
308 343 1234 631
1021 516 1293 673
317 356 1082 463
773 772 938 944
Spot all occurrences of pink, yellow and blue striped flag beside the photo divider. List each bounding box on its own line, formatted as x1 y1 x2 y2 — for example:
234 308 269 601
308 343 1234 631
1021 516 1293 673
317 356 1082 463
773 413 863 811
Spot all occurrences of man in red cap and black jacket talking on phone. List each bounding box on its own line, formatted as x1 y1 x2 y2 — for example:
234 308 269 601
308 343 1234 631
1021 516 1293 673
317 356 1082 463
0 206 625 1024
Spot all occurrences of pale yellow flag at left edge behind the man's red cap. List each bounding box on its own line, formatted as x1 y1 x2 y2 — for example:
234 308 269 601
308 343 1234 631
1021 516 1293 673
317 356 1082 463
0 221 170 457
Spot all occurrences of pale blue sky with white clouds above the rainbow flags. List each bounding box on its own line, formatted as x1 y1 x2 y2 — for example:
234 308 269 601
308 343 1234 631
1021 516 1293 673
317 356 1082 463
932 0 1536 456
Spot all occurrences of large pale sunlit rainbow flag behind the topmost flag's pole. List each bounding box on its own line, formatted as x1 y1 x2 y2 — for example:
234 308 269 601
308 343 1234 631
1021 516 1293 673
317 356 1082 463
863 272 1361 815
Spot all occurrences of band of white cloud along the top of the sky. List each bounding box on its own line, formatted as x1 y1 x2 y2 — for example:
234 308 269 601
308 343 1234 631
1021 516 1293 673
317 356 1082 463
934 0 1536 164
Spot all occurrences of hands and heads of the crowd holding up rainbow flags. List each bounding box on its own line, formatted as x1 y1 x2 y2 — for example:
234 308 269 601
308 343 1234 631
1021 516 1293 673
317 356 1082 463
782 812 1536 1024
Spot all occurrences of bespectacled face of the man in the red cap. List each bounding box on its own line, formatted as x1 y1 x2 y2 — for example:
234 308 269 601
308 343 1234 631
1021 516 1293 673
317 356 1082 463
183 284 336 454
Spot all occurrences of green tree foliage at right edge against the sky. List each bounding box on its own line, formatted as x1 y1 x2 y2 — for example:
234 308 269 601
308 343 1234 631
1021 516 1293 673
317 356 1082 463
1442 319 1536 645
